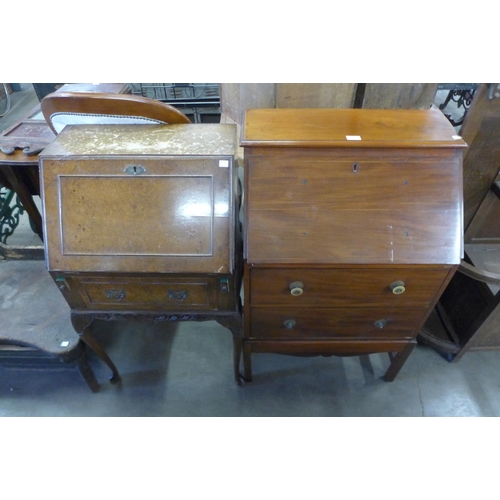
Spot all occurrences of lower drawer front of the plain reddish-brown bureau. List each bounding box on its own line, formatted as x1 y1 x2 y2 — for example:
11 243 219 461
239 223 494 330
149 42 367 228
247 307 427 339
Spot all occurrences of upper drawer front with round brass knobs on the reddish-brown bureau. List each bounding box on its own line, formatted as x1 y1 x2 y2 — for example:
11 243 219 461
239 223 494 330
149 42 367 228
250 267 450 308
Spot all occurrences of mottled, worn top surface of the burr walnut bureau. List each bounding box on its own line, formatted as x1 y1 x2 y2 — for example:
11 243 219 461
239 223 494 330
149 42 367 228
41 124 236 157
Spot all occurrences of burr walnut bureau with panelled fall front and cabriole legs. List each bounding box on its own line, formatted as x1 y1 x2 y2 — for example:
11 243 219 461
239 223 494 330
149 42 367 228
40 124 242 383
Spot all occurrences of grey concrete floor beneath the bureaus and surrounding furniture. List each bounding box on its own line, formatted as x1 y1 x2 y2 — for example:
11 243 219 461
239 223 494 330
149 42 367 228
0 84 500 417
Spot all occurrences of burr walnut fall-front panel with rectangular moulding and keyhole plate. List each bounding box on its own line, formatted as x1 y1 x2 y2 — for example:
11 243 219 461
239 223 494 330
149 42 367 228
42 157 234 273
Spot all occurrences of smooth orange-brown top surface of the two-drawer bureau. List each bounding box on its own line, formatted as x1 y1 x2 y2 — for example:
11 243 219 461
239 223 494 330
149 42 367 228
241 106 466 148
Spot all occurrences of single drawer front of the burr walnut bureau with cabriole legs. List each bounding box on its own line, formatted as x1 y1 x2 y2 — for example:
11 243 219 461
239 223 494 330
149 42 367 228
75 278 217 310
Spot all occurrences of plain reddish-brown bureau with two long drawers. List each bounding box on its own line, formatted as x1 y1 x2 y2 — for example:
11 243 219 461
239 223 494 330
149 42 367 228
241 107 466 381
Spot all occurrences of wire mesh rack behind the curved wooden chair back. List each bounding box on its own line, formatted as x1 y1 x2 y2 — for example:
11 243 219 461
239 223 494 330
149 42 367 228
130 83 221 123
